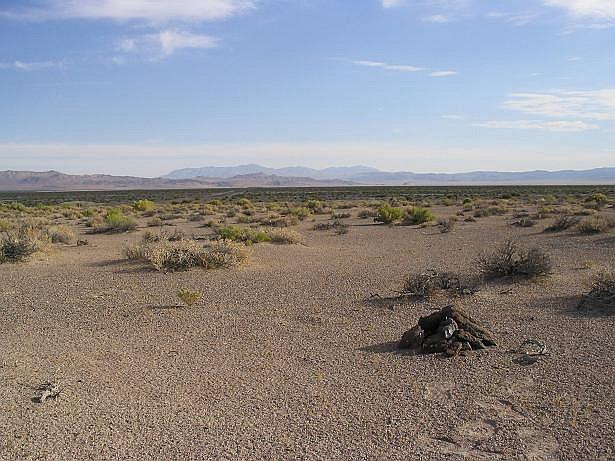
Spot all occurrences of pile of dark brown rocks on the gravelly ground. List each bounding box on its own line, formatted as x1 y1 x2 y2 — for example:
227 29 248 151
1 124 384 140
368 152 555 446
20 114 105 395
399 306 496 356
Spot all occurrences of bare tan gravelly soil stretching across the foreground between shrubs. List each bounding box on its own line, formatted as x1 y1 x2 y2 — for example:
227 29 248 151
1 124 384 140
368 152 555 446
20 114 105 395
0 208 615 460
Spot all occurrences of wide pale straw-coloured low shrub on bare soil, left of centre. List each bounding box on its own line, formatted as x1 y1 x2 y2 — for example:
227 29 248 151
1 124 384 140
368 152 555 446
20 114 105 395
124 235 247 272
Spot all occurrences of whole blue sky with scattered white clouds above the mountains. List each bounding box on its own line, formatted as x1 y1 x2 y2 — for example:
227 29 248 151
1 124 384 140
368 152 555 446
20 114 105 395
0 0 615 176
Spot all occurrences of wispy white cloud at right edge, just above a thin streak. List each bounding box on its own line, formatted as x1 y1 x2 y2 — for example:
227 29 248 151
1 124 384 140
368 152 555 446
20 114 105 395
504 89 615 120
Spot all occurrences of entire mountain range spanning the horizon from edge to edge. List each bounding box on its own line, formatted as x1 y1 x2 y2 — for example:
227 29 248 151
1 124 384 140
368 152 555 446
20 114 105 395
0 165 615 191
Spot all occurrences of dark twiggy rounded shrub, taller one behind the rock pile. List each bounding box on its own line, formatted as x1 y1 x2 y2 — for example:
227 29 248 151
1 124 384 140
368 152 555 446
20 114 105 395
478 241 553 279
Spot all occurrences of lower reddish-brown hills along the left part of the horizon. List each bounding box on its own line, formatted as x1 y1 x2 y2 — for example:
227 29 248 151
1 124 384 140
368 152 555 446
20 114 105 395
0 171 353 191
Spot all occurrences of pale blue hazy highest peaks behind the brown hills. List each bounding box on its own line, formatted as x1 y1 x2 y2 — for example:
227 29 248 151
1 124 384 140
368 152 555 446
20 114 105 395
163 164 379 179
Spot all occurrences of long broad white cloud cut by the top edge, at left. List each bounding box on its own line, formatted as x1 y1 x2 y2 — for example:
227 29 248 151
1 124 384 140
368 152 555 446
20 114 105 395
4 0 254 23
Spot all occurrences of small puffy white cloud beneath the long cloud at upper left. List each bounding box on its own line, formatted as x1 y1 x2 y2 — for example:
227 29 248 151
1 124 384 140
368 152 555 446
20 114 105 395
117 30 218 59
